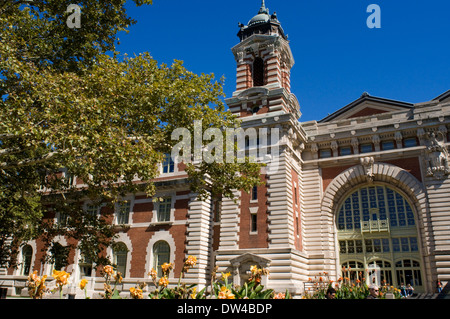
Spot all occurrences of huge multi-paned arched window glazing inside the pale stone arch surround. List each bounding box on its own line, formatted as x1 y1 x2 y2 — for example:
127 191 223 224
336 184 424 292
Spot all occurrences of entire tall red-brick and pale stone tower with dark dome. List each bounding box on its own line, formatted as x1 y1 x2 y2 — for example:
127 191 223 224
215 1 307 294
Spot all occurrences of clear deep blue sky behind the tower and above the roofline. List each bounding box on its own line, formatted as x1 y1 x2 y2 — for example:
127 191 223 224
117 0 450 122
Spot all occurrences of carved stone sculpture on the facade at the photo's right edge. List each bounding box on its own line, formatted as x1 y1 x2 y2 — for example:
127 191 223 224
425 131 450 179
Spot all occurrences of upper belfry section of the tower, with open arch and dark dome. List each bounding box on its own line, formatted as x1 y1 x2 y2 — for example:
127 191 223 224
226 0 301 119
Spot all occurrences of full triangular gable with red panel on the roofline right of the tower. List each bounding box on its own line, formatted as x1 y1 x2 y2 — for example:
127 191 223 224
319 92 413 123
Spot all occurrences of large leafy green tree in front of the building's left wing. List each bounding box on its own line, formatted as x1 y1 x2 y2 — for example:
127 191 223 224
0 0 261 266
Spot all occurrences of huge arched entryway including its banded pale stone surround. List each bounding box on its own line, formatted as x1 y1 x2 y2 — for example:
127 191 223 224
321 161 433 292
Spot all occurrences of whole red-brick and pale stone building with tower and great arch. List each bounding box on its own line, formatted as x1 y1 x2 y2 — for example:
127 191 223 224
0 1 450 295
